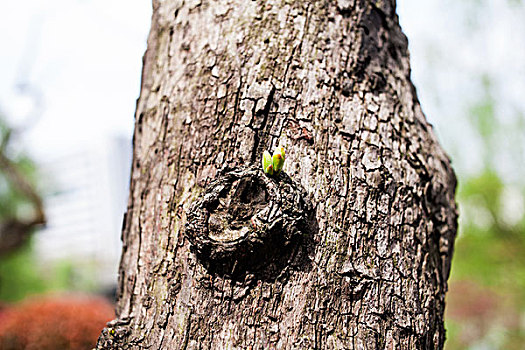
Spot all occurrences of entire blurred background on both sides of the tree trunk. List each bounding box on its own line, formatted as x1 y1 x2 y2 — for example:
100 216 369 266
0 0 525 349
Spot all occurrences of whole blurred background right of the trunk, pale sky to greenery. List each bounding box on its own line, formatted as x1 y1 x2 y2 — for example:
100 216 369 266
398 0 525 349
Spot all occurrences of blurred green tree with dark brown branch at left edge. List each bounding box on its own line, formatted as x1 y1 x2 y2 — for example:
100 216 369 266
0 115 46 300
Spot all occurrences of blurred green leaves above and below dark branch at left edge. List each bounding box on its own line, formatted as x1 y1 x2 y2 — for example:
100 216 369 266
0 118 77 302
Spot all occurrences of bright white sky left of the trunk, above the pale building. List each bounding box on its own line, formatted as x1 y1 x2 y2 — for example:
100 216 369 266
0 0 151 157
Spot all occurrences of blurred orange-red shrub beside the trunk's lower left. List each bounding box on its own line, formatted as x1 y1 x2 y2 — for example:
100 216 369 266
0 296 114 350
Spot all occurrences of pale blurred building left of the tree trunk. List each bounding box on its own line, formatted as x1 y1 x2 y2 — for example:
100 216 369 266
34 138 132 289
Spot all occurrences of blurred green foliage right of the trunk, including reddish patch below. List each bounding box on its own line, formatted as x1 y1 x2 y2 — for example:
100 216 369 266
446 76 525 349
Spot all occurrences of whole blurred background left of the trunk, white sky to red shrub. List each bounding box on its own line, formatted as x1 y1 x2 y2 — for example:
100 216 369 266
0 0 151 350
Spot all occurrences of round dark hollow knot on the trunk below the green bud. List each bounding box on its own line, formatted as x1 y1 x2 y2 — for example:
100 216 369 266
185 167 312 274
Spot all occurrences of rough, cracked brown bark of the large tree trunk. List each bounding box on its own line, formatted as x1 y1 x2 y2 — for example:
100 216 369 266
98 0 457 349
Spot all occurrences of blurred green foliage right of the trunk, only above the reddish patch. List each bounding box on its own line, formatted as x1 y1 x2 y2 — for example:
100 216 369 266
453 77 525 292
